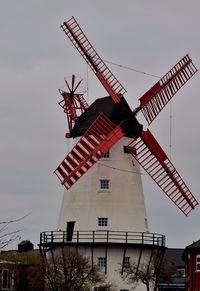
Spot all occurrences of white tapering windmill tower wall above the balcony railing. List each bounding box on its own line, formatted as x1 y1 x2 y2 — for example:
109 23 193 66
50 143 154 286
58 137 148 232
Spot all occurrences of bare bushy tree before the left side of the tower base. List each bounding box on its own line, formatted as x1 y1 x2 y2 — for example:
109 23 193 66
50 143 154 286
45 249 111 291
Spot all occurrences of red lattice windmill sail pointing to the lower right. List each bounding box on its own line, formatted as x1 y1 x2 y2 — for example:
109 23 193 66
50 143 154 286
127 130 198 215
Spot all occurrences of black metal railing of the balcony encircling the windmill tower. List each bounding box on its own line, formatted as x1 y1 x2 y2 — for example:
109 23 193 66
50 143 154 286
40 230 165 247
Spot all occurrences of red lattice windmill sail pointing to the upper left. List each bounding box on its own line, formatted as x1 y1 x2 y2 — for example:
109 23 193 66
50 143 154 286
61 17 126 103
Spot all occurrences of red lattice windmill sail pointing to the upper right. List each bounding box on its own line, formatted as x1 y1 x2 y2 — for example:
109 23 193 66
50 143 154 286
139 55 197 124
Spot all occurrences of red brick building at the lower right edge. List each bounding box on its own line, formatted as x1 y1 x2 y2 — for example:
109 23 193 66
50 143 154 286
183 240 200 291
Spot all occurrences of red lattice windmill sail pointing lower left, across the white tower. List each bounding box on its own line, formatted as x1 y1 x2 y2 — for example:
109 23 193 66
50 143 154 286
54 113 124 189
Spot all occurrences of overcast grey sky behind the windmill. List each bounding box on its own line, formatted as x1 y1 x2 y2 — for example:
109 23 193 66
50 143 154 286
0 0 200 251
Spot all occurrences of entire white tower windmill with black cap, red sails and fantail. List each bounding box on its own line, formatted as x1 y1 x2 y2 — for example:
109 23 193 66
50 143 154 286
40 17 198 290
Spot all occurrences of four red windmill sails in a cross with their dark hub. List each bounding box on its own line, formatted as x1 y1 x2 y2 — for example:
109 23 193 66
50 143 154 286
55 17 198 215
